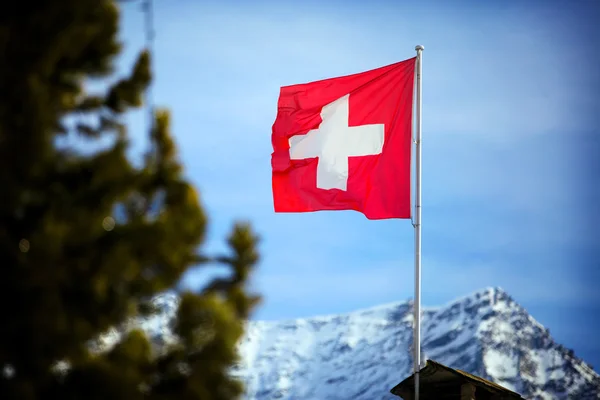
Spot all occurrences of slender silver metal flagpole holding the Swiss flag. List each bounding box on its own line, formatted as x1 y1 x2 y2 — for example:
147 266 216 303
413 45 425 400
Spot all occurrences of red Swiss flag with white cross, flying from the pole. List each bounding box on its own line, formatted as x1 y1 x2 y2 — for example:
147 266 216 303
271 58 416 219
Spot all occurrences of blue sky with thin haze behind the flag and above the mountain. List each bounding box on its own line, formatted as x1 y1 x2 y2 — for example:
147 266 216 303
119 0 600 367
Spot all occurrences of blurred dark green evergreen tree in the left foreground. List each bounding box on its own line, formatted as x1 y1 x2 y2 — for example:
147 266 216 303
0 0 258 400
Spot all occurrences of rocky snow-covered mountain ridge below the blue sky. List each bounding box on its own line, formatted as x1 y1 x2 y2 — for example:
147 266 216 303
102 288 600 400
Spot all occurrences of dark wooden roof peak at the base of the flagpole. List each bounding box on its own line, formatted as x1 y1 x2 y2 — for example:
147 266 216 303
391 360 524 400
